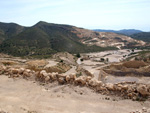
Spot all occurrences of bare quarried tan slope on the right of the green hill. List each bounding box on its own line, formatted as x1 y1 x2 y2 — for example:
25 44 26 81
73 27 145 48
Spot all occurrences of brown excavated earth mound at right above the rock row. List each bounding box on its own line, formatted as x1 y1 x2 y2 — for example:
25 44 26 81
100 60 150 77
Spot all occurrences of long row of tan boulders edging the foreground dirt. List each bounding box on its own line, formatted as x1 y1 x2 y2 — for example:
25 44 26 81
0 65 150 100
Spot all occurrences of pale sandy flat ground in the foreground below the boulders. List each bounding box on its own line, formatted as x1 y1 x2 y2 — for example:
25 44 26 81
0 75 150 113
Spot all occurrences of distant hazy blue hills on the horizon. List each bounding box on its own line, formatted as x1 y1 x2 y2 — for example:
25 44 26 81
94 29 143 36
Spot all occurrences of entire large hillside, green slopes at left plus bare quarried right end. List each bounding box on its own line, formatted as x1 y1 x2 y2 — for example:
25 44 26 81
0 21 145 56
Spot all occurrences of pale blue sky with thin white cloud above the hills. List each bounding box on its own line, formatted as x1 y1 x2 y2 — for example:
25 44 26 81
0 0 150 31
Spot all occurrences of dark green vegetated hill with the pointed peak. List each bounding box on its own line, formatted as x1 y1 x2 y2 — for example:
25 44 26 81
0 22 115 56
